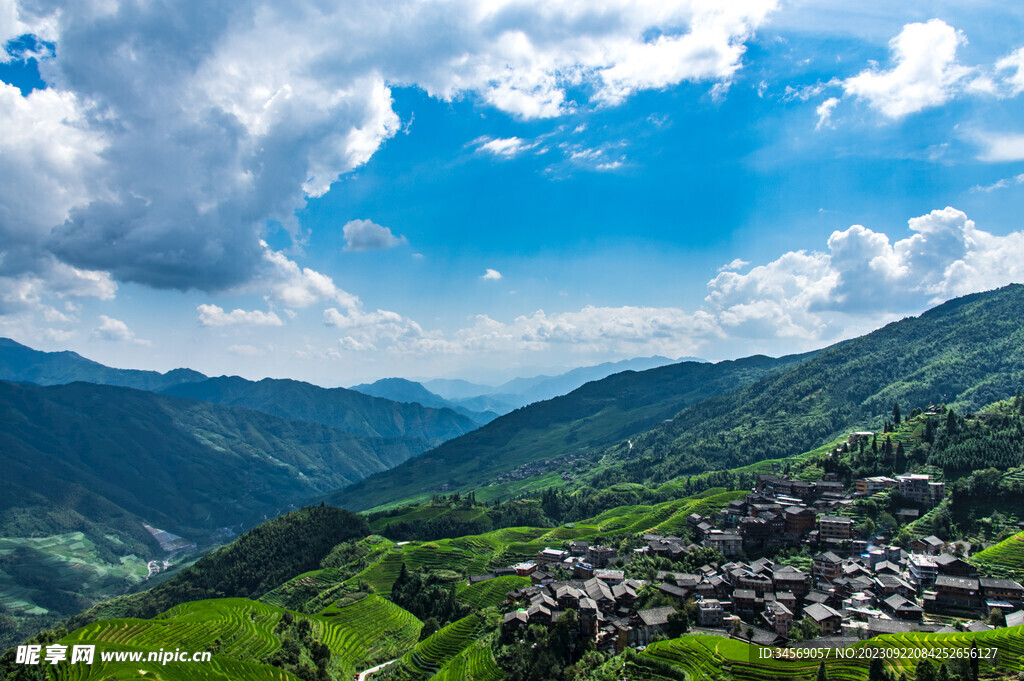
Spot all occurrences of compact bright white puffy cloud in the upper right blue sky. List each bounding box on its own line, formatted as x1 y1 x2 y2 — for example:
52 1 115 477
843 18 973 119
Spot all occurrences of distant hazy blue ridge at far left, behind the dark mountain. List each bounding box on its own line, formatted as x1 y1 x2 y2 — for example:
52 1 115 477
0 338 206 390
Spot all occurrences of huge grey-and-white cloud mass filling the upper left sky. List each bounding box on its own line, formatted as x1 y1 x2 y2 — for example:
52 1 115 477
0 0 778 305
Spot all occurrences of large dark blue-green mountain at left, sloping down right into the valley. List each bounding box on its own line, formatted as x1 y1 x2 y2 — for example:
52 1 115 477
0 382 424 539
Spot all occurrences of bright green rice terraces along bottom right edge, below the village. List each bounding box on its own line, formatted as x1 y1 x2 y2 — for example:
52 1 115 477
639 627 1024 681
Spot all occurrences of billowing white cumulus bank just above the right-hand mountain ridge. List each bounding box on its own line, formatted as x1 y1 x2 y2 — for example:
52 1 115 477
706 208 1024 341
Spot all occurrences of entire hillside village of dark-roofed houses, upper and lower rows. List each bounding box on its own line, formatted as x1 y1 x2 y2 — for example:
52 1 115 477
487 456 1024 650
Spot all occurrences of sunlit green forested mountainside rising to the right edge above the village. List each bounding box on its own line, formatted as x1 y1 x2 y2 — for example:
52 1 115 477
591 285 1024 484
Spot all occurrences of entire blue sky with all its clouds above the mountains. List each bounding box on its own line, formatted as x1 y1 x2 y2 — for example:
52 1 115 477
0 0 1024 385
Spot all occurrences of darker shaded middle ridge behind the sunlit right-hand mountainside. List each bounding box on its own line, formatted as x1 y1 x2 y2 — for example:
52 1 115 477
329 355 810 510
